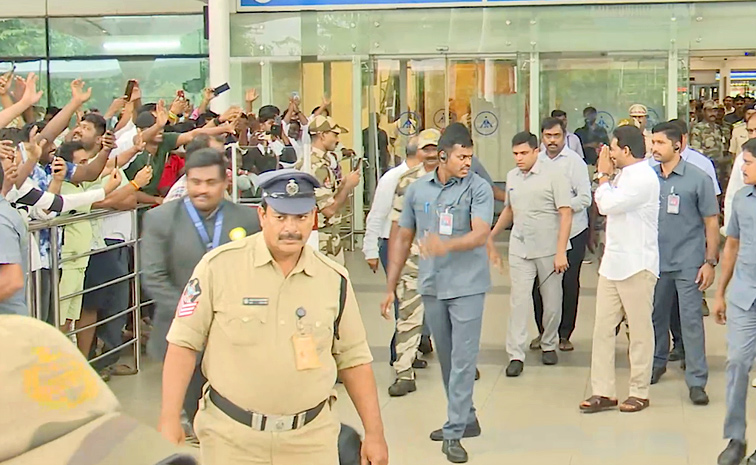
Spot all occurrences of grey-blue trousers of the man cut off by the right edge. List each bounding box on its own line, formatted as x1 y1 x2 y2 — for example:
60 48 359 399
720 302 756 442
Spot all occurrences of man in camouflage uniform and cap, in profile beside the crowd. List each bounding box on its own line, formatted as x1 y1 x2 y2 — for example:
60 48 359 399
309 115 360 265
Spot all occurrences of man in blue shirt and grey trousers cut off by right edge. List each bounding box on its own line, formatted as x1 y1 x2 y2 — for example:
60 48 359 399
713 139 756 465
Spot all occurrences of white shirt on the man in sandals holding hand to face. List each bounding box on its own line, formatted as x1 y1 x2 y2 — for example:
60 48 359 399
596 161 660 281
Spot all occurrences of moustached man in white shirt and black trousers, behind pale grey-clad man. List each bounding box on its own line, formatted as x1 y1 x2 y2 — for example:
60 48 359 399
530 118 591 351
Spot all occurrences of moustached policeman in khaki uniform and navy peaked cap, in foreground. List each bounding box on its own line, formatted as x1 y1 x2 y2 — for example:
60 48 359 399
160 170 388 465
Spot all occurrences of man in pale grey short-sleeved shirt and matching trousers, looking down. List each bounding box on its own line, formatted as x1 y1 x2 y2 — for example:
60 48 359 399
488 132 572 377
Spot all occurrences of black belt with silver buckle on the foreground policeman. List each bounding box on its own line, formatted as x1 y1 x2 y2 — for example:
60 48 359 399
209 386 328 432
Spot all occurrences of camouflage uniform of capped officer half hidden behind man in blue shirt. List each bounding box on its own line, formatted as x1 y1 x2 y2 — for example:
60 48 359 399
389 164 427 379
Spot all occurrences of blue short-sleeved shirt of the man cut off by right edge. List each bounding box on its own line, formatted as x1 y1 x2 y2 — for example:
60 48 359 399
727 186 756 310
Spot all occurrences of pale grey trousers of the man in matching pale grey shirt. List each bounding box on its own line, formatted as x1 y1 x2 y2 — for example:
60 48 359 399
507 254 562 362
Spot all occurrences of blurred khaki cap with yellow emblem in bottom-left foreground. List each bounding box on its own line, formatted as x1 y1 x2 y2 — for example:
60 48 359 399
0 315 196 465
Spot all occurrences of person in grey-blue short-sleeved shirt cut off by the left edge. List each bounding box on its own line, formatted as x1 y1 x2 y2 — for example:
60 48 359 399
0 168 29 315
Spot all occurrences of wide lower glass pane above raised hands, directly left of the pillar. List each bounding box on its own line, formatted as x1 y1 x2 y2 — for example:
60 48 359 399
50 58 208 111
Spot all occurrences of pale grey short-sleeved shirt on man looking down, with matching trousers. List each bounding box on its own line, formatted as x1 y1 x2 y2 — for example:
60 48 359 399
506 158 572 259
